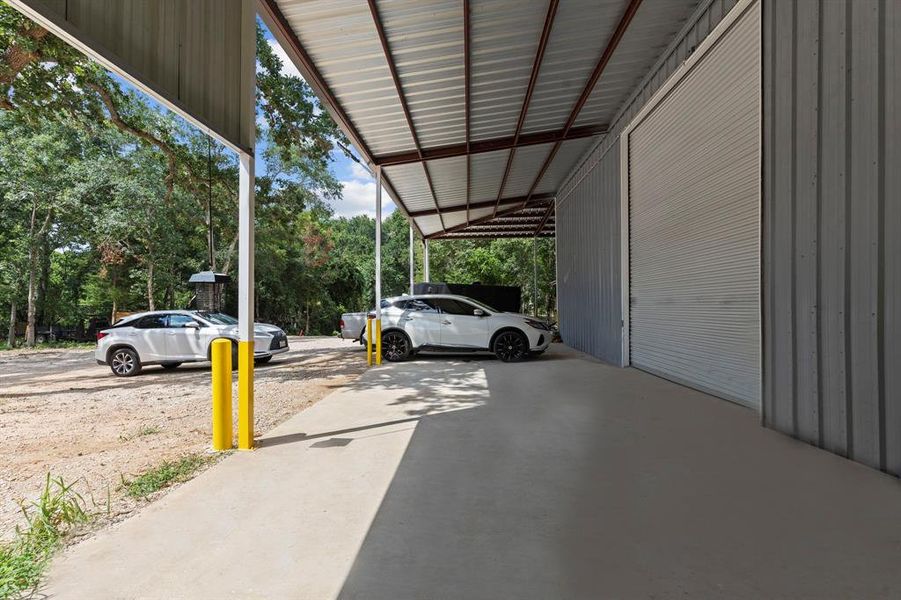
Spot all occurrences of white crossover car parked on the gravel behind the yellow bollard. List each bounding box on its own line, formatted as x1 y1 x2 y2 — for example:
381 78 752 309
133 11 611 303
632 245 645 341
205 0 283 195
94 310 288 377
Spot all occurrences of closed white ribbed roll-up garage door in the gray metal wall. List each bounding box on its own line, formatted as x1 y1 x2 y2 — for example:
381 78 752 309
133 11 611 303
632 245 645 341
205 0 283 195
626 2 760 406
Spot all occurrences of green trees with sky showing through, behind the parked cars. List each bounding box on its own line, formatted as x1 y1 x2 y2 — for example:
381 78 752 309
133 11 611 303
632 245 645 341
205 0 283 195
0 4 553 343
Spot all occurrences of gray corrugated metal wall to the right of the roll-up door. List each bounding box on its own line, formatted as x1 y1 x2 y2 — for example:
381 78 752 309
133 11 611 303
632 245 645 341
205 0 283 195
763 0 901 475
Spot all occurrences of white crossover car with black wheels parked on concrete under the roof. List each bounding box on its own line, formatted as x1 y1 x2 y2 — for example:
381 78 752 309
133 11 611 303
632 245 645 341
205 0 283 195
364 294 553 362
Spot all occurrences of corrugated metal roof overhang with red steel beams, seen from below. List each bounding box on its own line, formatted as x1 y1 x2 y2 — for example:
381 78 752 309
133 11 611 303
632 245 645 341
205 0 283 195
259 0 698 239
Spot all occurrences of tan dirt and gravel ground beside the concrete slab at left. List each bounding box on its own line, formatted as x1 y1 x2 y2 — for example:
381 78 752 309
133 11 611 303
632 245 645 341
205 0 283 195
0 337 366 539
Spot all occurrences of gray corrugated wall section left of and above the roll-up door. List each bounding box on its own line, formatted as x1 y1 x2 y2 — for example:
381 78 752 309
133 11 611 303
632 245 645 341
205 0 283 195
556 0 737 364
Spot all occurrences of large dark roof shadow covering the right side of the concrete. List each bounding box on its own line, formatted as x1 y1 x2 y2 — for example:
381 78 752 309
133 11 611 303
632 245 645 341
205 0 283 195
336 350 901 600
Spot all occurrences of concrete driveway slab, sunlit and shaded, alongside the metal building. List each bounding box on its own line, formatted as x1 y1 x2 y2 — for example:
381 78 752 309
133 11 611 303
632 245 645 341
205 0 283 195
43 346 901 600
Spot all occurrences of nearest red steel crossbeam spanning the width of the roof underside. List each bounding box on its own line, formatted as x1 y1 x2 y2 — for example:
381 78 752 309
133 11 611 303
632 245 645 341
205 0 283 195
373 125 608 167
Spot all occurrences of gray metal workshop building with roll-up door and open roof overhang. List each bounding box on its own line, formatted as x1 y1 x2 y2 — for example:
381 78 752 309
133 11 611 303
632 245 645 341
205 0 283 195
10 0 901 475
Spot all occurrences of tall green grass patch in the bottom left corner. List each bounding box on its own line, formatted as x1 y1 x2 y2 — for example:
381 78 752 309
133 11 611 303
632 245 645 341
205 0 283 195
0 473 92 599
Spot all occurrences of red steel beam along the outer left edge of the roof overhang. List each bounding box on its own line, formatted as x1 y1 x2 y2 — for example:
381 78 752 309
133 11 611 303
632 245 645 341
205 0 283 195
258 0 422 235
